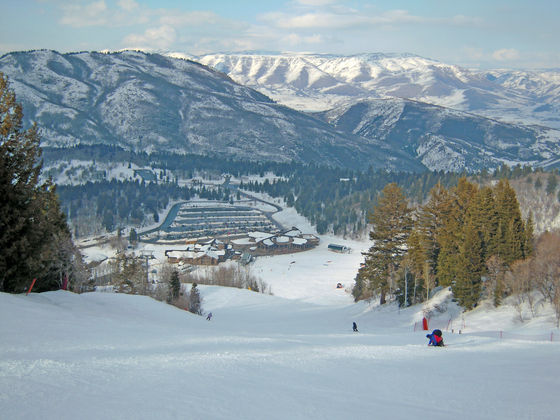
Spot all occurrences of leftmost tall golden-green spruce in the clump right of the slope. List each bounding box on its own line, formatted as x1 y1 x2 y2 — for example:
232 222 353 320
354 183 412 304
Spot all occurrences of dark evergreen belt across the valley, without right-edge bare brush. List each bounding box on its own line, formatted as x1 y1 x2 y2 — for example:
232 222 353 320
48 145 557 240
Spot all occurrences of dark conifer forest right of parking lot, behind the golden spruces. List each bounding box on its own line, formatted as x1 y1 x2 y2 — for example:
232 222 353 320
240 164 560 240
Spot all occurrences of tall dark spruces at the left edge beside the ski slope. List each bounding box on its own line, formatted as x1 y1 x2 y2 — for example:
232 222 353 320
0 73 81 293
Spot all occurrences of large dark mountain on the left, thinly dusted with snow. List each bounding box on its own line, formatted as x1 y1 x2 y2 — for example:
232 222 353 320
0 50 423 170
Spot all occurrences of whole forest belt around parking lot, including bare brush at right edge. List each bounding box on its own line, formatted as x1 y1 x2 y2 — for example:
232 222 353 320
50 146 560 237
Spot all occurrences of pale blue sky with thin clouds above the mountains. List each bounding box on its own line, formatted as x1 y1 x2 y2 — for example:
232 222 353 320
0 0 560 68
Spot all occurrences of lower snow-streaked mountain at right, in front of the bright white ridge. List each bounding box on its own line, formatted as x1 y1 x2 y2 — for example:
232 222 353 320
322 99 560 172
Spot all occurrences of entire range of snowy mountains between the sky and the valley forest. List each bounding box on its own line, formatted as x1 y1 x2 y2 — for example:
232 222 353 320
0 50 560 171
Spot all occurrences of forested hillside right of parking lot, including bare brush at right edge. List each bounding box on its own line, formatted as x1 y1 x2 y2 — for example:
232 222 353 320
241 165 560 236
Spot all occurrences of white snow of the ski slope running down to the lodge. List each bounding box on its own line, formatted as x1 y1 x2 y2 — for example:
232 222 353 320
4 203 560 420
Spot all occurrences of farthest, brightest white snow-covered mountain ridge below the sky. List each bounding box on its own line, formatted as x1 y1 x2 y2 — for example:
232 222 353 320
196 53 560 128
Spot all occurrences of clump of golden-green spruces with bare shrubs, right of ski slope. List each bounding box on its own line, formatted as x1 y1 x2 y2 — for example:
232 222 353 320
352 178 560 324
